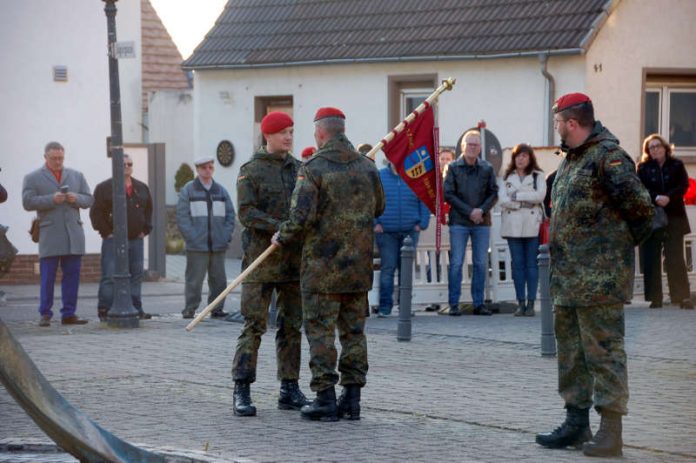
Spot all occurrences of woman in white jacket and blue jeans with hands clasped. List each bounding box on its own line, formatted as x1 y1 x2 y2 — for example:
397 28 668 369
498 143 546 317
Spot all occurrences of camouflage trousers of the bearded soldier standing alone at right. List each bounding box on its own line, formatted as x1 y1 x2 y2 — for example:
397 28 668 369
554 304 628 415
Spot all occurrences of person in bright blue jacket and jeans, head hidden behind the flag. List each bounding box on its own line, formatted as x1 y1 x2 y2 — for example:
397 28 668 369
375 162 430 317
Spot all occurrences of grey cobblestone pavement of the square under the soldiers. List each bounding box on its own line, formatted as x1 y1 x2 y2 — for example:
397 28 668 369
0 283 696 463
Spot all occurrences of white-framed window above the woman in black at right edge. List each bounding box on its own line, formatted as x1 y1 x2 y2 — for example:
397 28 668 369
643 83 696 154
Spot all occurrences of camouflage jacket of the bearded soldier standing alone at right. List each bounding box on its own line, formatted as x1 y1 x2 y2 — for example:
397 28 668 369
549 122 653 307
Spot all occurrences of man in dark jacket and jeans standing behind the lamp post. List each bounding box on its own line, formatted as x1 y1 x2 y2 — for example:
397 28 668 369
89 153 152 321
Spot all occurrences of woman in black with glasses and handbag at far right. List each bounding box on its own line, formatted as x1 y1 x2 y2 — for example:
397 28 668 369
638 133 694 309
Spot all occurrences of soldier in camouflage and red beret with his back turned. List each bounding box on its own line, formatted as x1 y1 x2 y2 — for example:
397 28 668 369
273 108 384 421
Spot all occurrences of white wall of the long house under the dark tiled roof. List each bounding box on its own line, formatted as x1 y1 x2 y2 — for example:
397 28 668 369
189 56 584 203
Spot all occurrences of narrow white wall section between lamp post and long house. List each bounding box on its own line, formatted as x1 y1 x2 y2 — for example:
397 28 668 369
148 90 194 205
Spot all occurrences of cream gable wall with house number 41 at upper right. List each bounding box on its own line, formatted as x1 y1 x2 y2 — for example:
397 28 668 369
585 0 696 158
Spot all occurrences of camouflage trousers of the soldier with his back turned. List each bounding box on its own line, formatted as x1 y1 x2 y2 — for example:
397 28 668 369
302 292 368 392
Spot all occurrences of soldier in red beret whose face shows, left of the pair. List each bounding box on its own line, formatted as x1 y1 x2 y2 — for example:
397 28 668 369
232 112 308 416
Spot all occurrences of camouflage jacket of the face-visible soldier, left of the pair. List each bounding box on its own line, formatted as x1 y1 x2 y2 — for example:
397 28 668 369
237 148 301 283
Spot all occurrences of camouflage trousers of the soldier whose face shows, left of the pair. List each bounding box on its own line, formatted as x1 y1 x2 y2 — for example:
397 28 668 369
232 281 302 383
